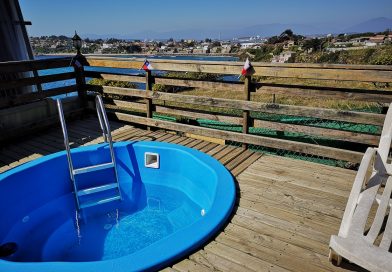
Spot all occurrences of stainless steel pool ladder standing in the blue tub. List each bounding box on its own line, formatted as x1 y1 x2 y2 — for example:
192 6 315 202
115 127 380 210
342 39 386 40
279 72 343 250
57 95 122 210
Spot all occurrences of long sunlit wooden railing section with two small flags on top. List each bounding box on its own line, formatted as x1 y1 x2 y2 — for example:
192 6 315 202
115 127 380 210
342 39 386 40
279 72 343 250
82 57 392 162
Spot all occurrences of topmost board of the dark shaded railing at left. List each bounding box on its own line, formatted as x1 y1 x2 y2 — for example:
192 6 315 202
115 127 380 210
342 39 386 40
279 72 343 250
0 57 72 73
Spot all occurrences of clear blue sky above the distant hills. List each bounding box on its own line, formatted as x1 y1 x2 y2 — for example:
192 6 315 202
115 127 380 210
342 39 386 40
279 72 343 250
20 0 392 36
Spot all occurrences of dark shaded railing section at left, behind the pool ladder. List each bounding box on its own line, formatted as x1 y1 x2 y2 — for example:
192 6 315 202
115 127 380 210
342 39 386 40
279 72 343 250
0 57 85 142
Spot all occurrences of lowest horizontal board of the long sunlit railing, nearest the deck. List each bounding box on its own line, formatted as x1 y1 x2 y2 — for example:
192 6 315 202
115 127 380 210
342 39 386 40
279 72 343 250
109 111 363 163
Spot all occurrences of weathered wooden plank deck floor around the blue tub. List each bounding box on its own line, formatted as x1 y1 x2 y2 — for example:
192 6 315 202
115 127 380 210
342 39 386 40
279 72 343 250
0 118 359 271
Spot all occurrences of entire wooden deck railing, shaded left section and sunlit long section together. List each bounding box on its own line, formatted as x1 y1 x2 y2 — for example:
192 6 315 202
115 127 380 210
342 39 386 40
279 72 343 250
0 54 392 163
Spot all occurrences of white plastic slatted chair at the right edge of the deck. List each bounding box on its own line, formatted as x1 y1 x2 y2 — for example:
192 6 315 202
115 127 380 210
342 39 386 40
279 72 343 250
329 103 392 271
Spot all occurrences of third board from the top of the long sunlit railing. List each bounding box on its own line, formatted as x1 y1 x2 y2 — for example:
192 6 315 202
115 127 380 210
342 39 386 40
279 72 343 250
88 85 385 126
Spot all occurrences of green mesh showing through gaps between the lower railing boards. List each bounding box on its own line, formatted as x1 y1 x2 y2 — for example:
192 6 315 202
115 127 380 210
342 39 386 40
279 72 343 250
153 108 381 168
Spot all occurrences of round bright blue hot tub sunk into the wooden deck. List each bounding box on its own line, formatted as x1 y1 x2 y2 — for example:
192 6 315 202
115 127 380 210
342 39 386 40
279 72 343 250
0 142 235 272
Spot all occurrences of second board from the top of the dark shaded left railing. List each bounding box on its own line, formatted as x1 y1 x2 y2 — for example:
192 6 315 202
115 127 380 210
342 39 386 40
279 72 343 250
0 72 75 89
